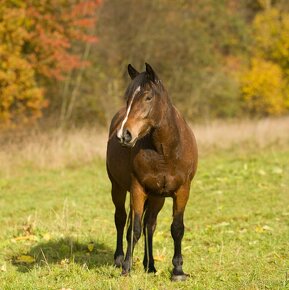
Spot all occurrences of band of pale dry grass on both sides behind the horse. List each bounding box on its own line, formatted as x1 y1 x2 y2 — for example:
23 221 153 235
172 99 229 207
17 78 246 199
0 117 289 175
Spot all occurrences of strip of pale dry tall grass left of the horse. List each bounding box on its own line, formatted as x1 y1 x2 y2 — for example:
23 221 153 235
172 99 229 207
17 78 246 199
0 128 107 173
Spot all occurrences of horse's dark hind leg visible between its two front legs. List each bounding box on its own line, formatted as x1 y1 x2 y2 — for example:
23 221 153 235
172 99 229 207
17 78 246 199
143 196 165 273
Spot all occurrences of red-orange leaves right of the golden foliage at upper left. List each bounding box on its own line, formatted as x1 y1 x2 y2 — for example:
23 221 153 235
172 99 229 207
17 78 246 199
27 0 99 80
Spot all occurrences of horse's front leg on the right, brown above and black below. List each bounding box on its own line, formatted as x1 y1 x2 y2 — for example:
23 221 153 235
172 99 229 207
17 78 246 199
171 185 190 281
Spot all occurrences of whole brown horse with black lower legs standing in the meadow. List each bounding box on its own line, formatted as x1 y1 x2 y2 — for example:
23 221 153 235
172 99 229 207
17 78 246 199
106 64 198 280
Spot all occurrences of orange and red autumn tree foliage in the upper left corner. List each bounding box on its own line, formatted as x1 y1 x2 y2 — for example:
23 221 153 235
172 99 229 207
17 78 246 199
0 0 99 127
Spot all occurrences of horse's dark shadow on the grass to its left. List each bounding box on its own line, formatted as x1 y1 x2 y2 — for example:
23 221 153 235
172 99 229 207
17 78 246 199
14 237 113 272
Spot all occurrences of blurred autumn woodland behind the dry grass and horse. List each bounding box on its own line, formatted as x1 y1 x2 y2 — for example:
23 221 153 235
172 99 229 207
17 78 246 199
0 0 289 131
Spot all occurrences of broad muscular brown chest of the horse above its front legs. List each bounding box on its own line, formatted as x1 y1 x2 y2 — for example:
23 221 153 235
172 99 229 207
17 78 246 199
134 151 183 197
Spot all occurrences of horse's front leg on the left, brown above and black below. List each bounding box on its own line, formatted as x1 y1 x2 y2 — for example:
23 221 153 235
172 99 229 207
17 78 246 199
122 179 147 275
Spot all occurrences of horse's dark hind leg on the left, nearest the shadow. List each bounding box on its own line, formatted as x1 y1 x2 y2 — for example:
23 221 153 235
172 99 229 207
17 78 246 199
111 182 126 267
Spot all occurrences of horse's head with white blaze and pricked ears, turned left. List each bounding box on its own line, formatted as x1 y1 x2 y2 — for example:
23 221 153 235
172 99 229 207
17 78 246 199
117 63 164 147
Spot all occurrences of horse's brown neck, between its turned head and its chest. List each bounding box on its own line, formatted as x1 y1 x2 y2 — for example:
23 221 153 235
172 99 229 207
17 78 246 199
152 106 180 158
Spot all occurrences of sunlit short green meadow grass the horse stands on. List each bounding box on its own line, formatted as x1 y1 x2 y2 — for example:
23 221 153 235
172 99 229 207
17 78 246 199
0 148 289 289
